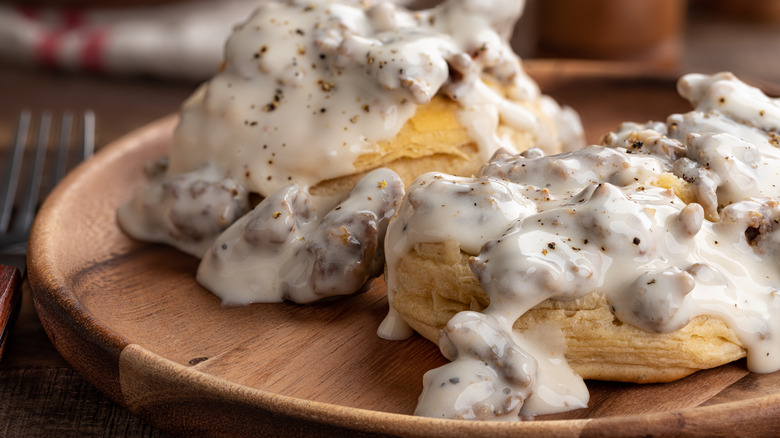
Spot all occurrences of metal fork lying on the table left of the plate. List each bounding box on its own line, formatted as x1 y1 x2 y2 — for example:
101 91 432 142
0 110 95 358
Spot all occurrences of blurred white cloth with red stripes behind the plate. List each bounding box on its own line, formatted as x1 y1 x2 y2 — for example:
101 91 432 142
0 0 263 79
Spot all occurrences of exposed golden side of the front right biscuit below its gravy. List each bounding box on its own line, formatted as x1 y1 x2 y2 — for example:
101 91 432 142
388 241 746 383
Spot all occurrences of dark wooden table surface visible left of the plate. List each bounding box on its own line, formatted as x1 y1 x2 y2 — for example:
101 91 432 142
0 65 197 437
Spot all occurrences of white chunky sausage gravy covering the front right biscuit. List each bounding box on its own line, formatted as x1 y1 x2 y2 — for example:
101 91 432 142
386 73 780 420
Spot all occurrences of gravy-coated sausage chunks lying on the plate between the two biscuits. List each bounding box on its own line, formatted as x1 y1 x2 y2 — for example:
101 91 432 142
197 169 404 304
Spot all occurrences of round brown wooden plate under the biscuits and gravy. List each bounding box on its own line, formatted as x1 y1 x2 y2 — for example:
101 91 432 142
29 69 780 436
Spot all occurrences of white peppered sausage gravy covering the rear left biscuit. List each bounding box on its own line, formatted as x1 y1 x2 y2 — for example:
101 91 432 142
114 0 582 257
